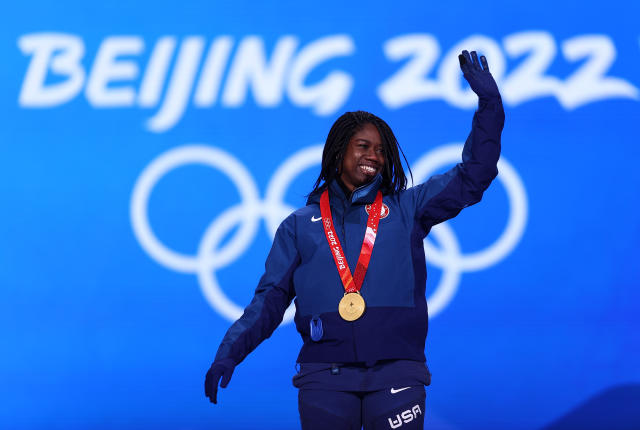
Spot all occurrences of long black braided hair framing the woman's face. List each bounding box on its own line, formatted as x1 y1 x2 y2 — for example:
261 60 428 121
311 110 413 194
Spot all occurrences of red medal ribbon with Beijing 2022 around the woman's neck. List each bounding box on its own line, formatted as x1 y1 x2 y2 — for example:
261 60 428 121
320 190 382 293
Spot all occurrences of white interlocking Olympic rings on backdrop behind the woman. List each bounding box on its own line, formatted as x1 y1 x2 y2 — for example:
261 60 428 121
130 143 528 323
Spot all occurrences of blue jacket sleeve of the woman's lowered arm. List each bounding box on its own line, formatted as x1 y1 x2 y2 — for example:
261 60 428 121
215 214 300 365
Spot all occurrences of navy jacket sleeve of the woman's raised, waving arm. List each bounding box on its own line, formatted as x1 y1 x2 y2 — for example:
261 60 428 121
413 97 504 232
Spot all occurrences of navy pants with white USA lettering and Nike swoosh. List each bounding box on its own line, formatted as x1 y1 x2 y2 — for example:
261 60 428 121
298 385 425 430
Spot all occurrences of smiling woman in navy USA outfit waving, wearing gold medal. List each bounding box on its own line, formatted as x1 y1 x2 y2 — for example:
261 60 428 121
205 51 504 429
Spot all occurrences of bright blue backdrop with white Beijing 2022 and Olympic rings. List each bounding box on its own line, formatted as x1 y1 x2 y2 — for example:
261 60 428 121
0 0 640 429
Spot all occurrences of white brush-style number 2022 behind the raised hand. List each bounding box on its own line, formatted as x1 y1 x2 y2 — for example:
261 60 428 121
377 31 639 110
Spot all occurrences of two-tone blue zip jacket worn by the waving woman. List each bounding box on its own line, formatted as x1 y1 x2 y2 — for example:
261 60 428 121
216 98 504 364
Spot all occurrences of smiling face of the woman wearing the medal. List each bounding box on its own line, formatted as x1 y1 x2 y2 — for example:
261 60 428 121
340 124 385 191
